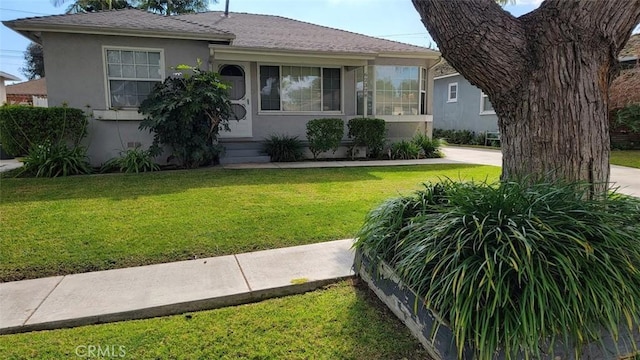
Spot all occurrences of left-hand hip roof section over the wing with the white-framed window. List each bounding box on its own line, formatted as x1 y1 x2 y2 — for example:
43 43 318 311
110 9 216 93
2 9 233 40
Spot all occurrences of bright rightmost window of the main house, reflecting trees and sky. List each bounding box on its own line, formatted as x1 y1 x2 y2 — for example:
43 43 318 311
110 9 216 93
374 66 420 115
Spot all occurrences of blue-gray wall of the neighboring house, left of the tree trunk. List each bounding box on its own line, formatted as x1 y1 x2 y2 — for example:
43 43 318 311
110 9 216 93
433 75 498 133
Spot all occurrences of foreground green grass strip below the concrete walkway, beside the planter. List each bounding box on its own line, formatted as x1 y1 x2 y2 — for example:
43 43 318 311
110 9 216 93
0 281 428 359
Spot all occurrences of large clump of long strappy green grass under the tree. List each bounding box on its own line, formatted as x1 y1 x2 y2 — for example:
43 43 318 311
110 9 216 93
355 181 640 359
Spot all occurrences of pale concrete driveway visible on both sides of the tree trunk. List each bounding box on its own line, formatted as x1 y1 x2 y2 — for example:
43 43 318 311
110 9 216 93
442 146 640 197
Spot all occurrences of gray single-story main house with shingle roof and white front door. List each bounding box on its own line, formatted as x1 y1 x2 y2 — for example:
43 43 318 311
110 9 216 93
3 9 440 165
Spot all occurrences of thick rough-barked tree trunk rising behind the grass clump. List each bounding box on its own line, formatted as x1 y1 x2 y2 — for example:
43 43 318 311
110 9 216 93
413 0 640 195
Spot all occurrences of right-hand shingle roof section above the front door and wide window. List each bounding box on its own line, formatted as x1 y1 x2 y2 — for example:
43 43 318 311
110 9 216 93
176 12 439 56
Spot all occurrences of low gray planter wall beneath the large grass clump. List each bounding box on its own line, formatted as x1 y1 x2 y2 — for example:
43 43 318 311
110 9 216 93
354 249 640 360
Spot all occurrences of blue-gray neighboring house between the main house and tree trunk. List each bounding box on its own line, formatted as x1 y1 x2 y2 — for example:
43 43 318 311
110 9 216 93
433 62 498 133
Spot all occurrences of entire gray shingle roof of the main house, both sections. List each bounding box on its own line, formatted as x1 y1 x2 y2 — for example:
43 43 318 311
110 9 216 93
3 9 440 57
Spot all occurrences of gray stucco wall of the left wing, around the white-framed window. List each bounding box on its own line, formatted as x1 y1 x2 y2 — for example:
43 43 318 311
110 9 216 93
43 33 209 166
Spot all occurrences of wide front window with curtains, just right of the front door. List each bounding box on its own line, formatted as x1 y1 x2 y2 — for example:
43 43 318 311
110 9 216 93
259 65 342 112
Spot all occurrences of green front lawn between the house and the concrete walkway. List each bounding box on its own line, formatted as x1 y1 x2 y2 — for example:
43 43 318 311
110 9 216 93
0 165 500 281
